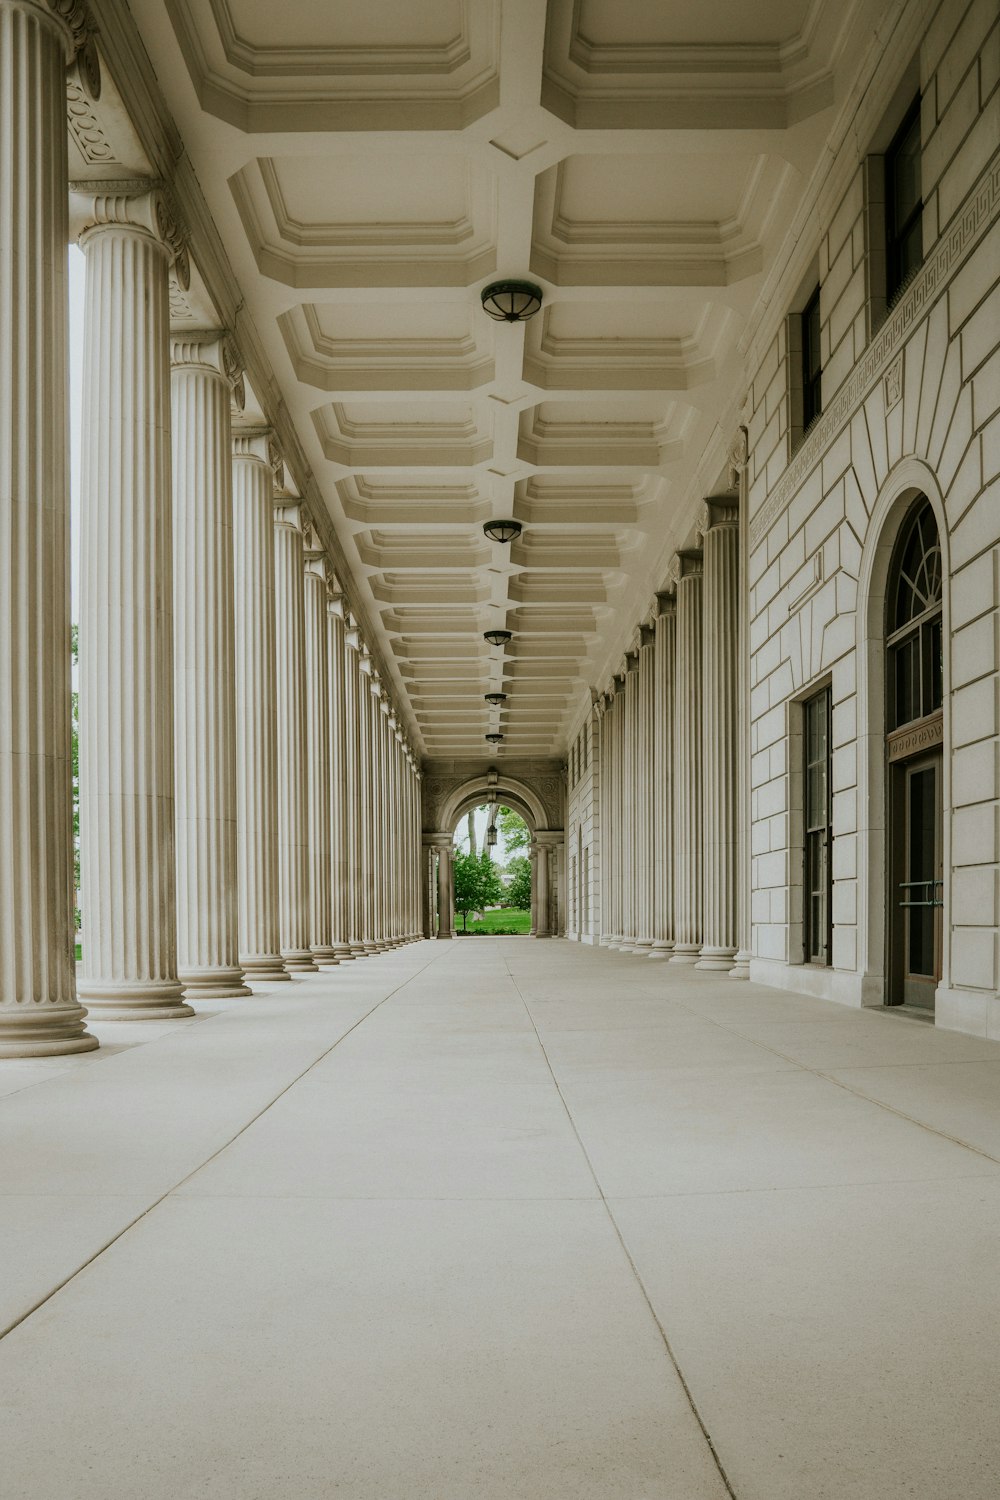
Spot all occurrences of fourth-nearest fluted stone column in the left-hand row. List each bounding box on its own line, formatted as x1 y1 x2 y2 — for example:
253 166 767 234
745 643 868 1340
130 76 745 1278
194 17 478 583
232 429 289 984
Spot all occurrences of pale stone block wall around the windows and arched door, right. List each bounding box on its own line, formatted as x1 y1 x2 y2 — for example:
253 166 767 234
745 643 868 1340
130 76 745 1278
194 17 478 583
745 0 1000 1035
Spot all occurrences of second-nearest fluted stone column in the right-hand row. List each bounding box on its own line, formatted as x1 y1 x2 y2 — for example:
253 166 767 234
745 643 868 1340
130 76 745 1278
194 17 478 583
670 551 703 963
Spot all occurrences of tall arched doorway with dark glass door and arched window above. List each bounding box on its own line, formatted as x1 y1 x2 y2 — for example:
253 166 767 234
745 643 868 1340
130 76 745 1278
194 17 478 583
886 498 945 1011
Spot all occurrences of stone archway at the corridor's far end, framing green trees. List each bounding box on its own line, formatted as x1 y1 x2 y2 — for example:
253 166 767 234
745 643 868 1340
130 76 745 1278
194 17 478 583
424 771 564 938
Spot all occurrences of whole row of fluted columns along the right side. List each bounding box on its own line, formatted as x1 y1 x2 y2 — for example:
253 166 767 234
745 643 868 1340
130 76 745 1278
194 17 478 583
597 497 747 978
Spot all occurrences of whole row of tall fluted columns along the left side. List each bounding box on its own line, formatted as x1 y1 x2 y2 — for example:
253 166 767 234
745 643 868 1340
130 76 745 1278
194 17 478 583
0 0 420 1056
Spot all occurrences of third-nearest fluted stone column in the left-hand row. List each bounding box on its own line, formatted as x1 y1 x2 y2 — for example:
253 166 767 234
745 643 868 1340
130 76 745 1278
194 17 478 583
171 333 250 999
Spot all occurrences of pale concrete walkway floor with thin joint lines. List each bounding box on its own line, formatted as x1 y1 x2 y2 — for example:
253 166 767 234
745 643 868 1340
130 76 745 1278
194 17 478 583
0 938 1000 1500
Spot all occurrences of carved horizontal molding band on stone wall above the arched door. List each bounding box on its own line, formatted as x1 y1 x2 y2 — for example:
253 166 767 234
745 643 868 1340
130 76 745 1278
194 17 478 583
750 147 1000 551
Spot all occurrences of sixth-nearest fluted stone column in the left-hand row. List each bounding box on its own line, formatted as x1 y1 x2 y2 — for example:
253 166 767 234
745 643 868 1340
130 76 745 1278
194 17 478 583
303 539 337 968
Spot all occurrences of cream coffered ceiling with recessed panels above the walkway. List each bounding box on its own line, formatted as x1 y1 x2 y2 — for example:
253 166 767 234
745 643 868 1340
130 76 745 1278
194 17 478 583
115 0 883 758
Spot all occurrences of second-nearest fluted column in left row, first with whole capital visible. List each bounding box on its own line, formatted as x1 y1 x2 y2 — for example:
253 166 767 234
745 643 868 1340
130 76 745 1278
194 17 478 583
74 183 192 1020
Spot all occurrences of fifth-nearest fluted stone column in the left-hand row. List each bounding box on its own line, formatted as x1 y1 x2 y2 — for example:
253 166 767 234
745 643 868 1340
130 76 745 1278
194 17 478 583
274 503 316 974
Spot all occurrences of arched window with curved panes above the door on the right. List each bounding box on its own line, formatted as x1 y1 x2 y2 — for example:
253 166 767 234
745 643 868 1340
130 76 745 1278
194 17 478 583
886 497 943 731
